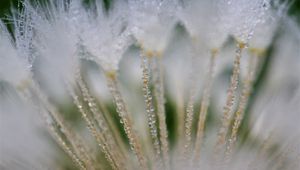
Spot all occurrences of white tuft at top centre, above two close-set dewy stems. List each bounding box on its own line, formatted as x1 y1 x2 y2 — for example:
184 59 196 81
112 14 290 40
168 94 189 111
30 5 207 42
129 0 178 53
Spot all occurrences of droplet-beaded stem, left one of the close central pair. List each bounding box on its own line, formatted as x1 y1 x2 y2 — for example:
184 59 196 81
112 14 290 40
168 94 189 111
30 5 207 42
141 53 161 169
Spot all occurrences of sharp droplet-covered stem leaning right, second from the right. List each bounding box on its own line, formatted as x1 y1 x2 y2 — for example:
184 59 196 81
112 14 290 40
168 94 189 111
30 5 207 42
215 43 245 156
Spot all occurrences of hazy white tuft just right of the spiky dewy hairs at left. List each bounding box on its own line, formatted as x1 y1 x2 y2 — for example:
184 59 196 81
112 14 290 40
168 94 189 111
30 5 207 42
27 1 79 82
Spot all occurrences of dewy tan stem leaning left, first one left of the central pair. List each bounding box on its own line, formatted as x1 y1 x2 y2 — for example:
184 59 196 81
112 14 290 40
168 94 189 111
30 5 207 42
106 72 148 169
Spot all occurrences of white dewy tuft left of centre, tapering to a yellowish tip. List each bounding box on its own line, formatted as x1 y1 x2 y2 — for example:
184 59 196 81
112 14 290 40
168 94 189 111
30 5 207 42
78 1 133 71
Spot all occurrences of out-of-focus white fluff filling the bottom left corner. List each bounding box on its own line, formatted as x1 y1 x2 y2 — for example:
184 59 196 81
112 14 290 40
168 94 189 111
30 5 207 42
0 83 56 169
